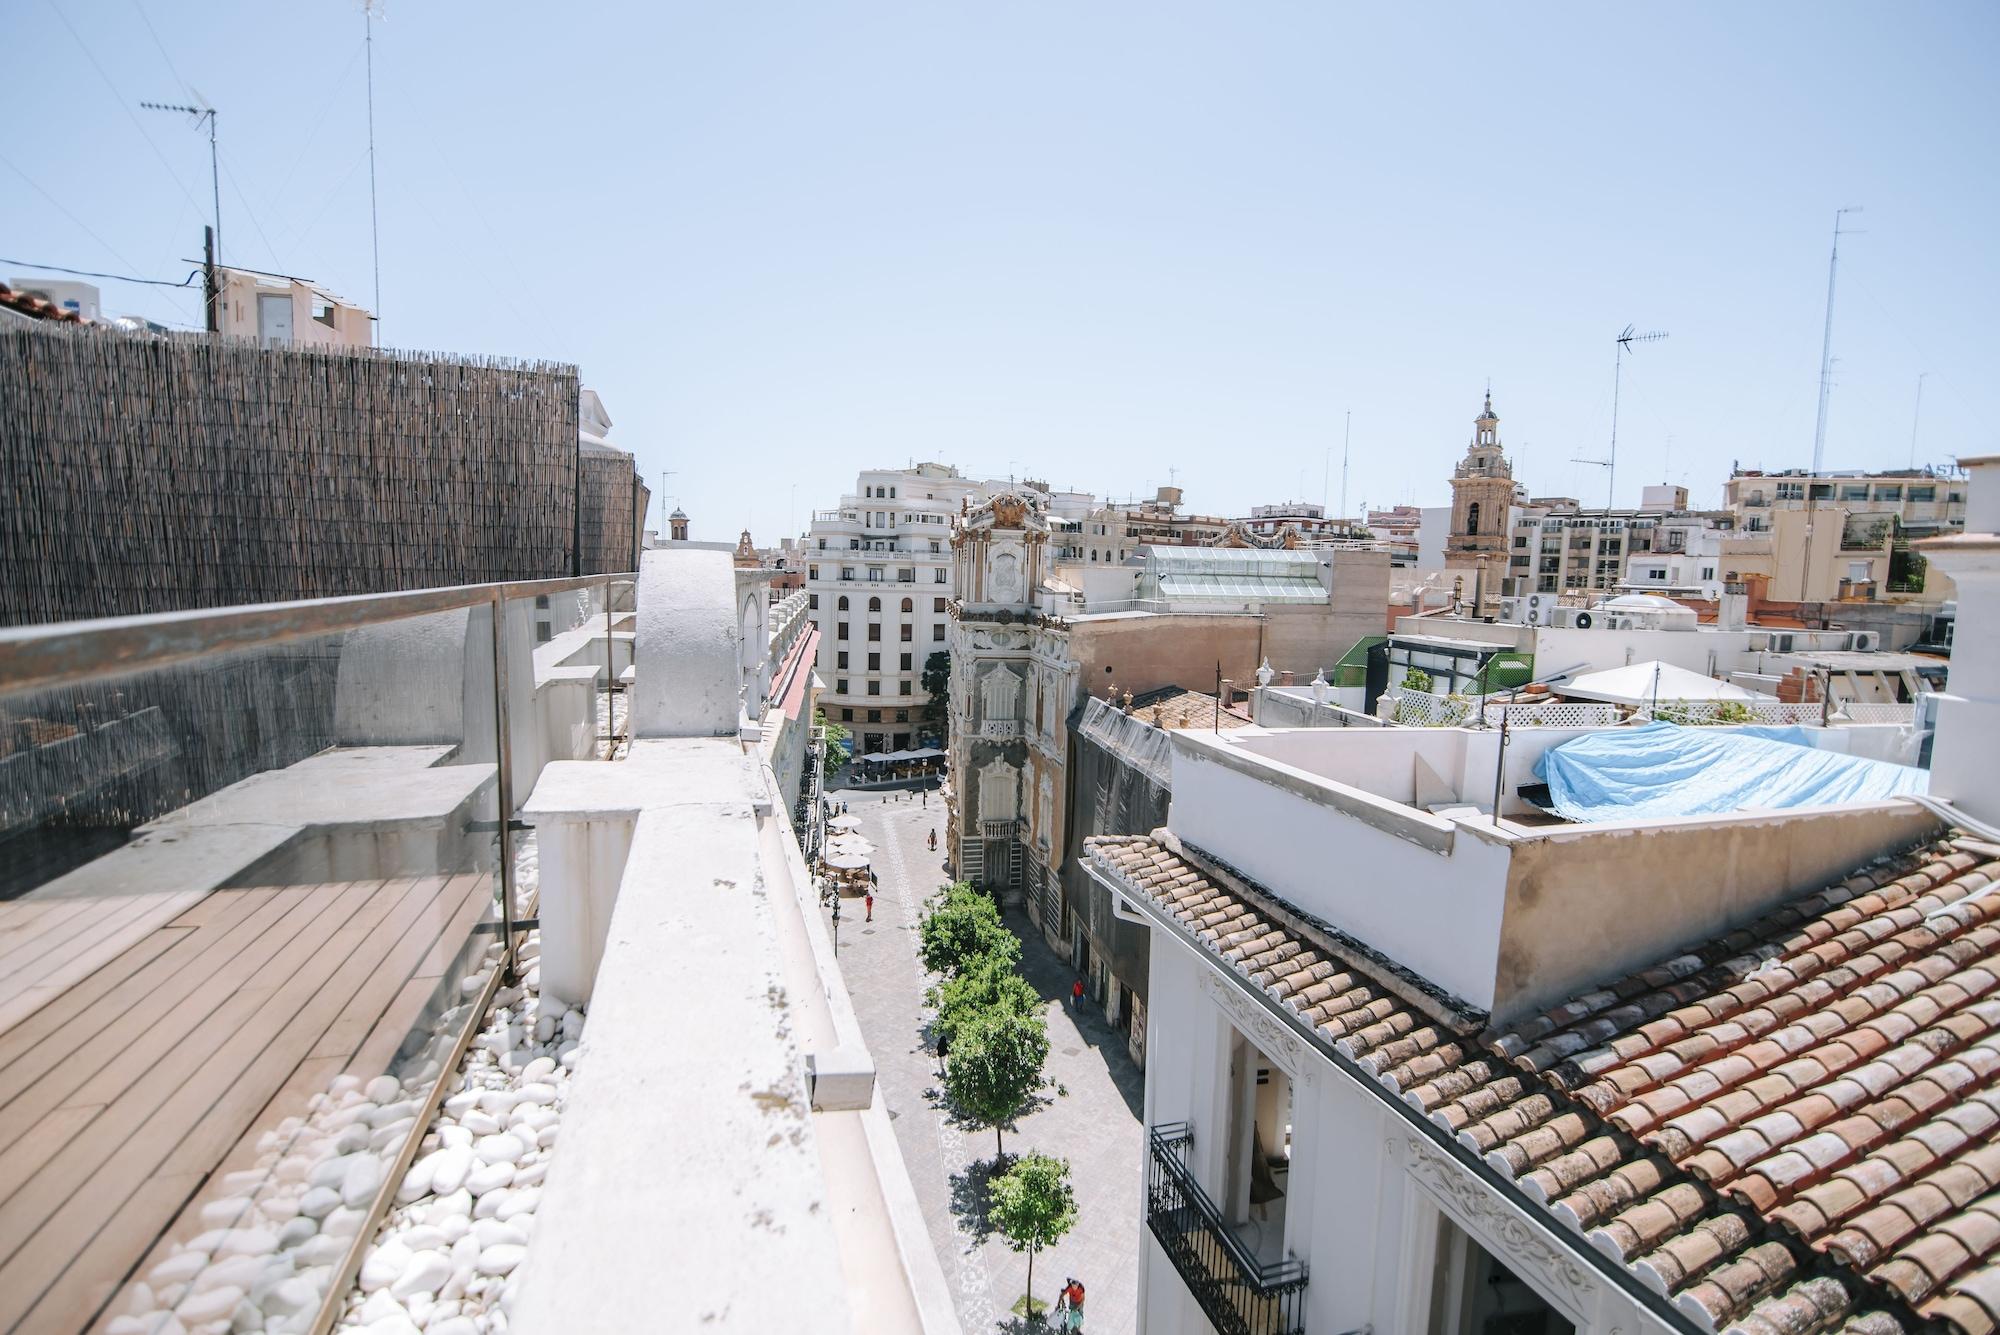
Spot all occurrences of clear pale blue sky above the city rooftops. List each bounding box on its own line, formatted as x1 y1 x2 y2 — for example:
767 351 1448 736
0 0 2000 540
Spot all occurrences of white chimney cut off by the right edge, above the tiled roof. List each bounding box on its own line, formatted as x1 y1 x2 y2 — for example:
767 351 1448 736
1916 454 2000 827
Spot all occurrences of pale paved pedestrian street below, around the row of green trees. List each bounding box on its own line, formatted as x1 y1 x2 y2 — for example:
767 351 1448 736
830 791 1144 1335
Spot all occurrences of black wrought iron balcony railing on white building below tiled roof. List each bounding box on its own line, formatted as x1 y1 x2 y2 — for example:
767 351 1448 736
1146 1121 1306 1335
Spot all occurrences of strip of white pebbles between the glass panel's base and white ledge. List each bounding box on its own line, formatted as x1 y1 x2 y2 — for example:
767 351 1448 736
336 939 584 1335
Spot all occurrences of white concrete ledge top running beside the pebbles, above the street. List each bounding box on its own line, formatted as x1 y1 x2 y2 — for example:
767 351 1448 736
512 739 850 1335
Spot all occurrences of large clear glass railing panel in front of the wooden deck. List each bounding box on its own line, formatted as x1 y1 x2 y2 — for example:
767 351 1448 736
0 600 504 1331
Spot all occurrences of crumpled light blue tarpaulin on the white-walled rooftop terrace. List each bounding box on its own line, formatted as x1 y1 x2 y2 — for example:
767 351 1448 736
1534 723 1930 821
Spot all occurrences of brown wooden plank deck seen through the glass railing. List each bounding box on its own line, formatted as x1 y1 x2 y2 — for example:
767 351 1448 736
0 875 492 1331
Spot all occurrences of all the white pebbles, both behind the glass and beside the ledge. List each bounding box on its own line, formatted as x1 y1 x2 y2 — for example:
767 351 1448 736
102 937 584 1335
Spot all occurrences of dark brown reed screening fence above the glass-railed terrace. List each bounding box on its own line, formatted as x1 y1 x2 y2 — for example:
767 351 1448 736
0 326 644 626
